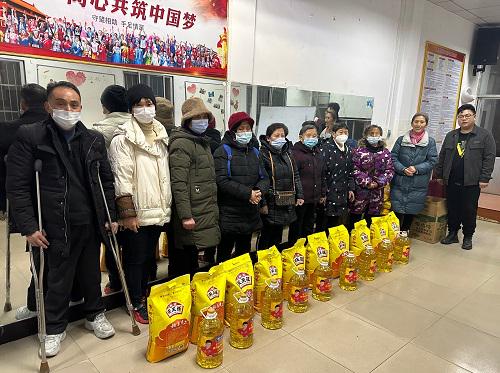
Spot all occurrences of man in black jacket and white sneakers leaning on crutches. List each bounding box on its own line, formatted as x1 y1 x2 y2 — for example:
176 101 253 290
7 82 117 356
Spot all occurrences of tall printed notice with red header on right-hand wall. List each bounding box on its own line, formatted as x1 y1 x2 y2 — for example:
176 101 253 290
418 42 465 147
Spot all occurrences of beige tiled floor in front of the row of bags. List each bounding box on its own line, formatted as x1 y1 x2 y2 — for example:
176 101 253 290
0 222 500 373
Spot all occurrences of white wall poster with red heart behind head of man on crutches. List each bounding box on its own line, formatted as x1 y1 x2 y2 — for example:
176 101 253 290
38 65 115 128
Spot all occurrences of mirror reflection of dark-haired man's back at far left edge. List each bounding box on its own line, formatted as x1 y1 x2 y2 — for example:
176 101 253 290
0 83 47 213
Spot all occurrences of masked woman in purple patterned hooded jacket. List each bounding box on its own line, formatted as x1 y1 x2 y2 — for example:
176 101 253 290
350 125 394 229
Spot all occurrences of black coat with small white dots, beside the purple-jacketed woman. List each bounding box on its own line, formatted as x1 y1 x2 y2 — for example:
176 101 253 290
321 140 355 216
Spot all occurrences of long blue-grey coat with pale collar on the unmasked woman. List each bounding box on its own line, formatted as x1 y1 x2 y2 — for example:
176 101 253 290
391 132 437 215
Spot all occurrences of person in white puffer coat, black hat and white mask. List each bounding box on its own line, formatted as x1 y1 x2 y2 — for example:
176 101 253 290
109 84 172 324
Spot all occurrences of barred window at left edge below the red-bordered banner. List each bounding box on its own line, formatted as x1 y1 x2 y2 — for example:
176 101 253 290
0 59 24 122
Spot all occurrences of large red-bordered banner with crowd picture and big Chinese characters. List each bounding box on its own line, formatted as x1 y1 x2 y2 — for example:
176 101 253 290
0 0 227 79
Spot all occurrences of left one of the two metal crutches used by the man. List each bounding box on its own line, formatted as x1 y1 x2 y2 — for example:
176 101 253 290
29 159 50 373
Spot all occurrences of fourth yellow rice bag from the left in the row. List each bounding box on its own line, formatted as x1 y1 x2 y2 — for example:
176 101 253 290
254 246 283 312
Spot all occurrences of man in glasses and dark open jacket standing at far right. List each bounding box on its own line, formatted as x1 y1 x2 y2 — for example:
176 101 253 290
434 104 496 250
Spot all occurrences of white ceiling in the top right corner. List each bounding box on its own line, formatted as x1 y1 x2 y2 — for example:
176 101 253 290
429 0 500 25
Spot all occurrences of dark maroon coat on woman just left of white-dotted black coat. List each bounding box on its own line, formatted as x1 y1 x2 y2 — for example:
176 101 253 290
292 141 326 204
